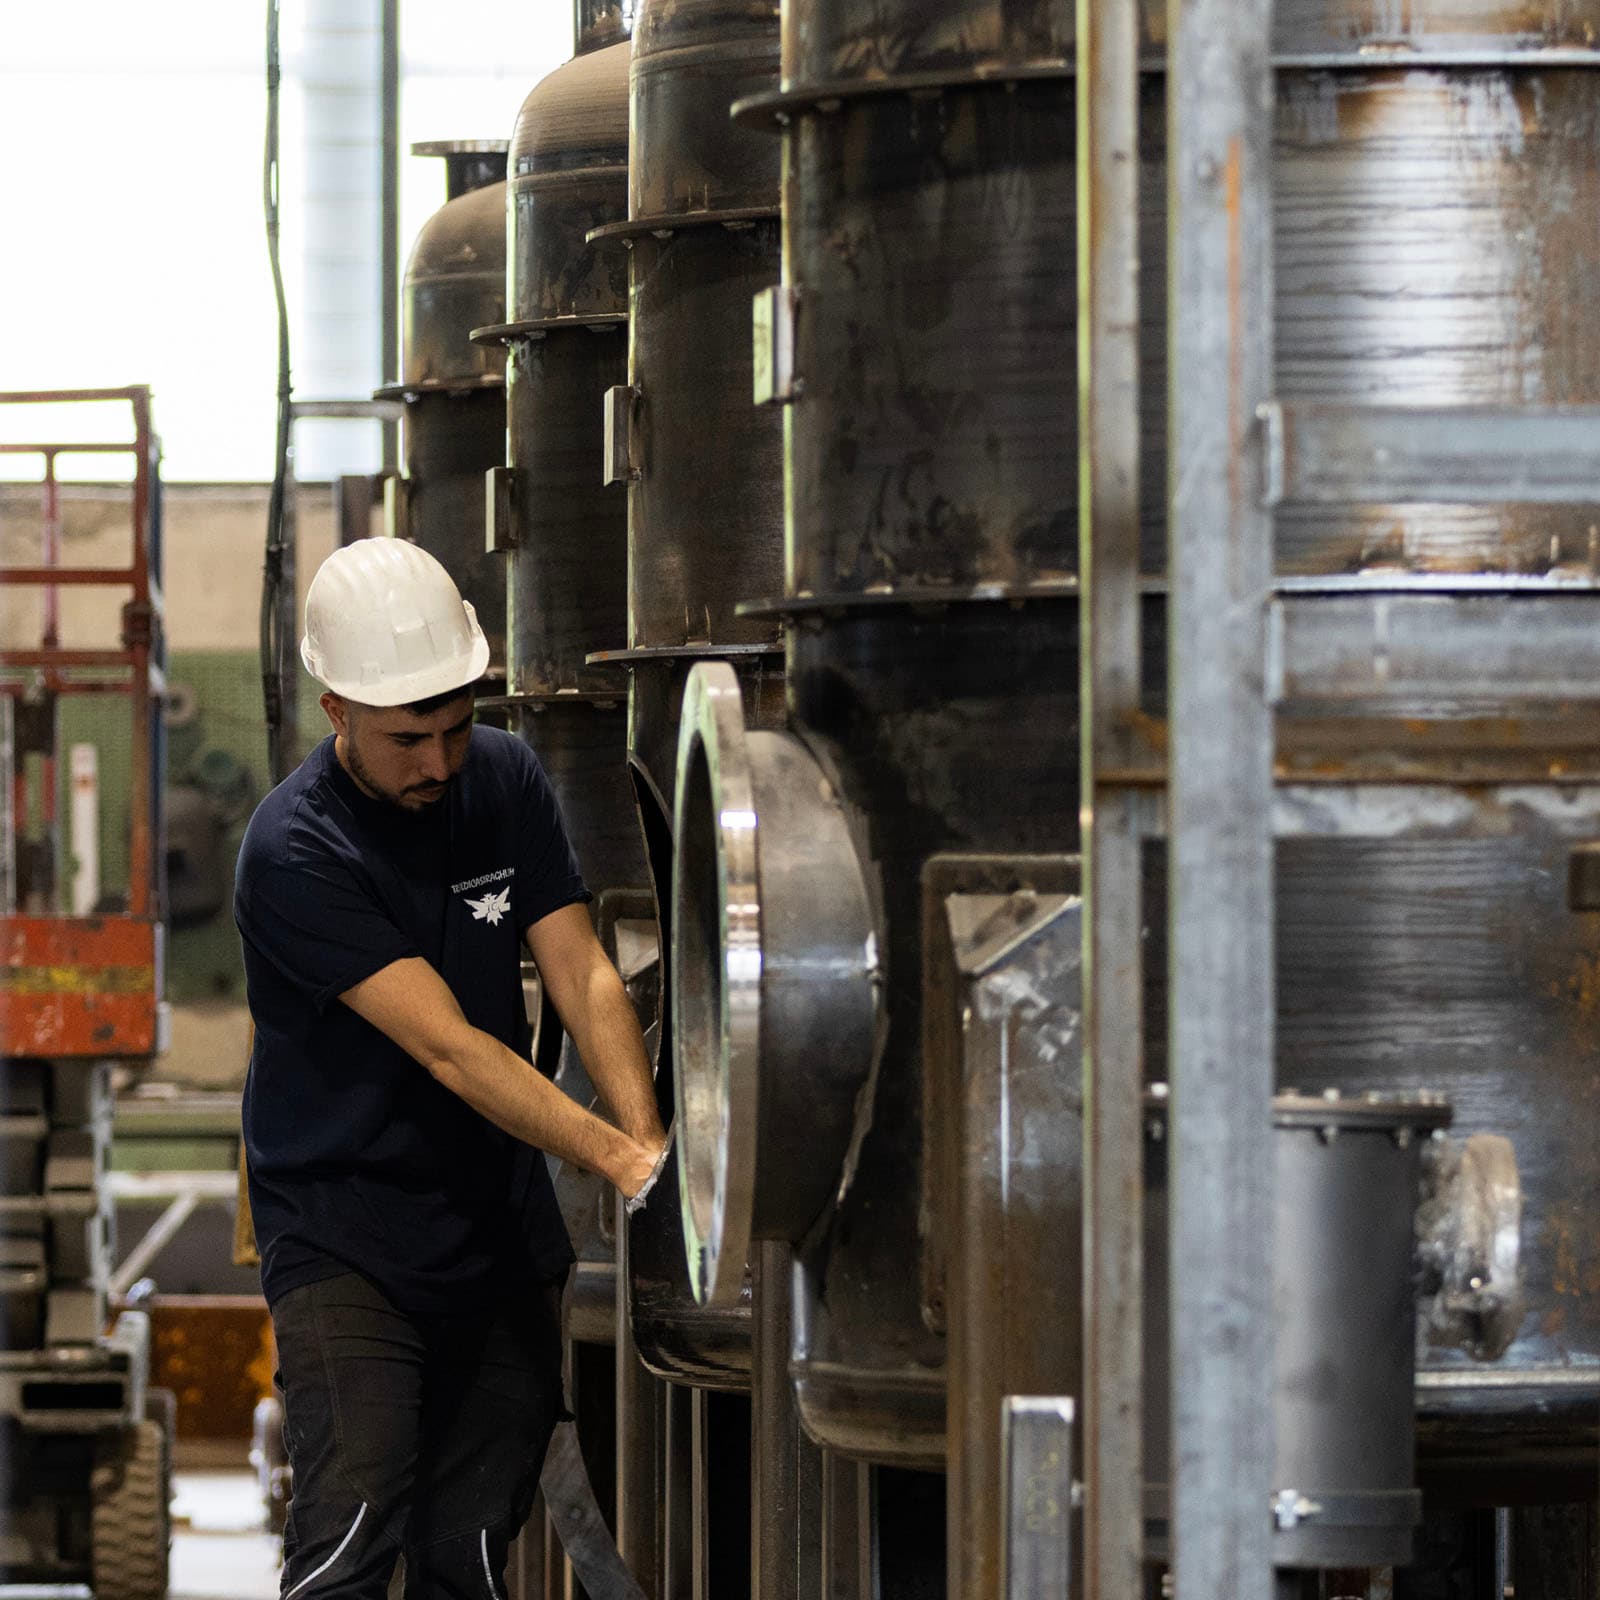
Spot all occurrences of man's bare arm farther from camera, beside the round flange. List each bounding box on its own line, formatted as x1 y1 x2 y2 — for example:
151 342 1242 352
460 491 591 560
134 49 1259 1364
523 906 667 1150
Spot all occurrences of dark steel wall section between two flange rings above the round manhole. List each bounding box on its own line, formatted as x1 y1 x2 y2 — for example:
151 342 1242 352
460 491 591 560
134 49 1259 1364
784 82 1077 597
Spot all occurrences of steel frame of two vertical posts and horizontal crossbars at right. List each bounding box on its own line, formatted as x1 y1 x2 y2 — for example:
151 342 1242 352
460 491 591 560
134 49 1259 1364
1077 12 1600 1600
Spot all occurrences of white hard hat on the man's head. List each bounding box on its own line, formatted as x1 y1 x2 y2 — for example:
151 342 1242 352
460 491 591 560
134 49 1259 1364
301 539 490 706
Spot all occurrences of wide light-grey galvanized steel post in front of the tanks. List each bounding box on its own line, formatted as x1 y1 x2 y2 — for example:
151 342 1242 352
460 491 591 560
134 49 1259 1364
1166 0 1275 1600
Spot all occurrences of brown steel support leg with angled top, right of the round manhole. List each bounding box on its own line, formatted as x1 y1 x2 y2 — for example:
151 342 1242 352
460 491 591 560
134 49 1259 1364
925 876 1088 1600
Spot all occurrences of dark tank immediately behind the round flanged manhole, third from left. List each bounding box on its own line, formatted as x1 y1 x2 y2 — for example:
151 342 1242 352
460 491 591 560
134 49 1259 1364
595 0 782 1389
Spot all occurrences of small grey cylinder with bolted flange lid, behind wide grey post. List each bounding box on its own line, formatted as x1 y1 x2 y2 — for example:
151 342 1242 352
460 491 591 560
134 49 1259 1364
1146 1085 1450 1568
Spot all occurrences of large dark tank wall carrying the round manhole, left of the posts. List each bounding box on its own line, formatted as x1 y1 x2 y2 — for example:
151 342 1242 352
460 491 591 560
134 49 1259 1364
723 3 1077 1466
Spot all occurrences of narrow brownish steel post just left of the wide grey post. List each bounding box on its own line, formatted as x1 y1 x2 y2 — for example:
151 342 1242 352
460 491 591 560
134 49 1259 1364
1077 0 1144 1600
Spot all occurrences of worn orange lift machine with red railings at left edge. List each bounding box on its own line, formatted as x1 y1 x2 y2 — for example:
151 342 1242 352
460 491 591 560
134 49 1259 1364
0 389 173 1600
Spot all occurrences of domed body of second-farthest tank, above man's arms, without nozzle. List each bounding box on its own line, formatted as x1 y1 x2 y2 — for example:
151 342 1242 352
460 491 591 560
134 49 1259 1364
493 43 645 888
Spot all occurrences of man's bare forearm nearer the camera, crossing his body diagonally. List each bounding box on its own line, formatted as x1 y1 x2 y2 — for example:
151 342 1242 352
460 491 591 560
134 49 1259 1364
339 957 659 1197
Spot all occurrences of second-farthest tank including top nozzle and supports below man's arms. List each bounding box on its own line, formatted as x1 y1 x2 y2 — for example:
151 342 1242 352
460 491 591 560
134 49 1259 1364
478 31 659 1592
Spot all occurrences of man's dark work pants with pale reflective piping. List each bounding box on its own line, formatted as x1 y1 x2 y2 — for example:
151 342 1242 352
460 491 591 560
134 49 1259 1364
272 1274 563 1600
